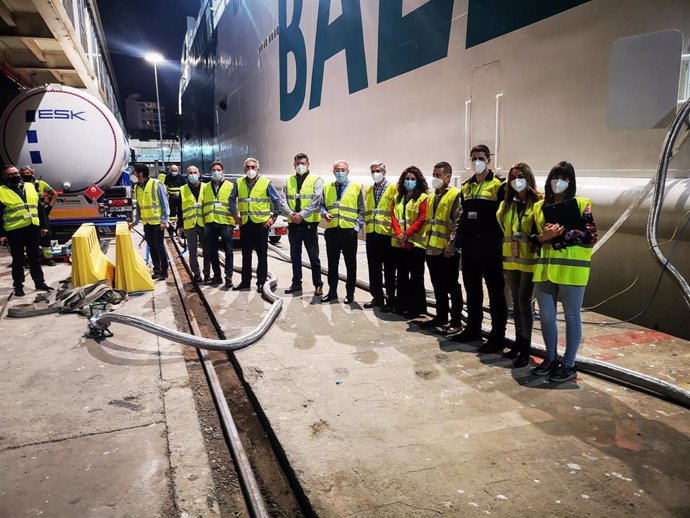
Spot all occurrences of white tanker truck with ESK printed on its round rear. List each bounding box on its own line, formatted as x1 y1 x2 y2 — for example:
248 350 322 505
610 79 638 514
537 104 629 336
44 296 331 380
0 84 133 241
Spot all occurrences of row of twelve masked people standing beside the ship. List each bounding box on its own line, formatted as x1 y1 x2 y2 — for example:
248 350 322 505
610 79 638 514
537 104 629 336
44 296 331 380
135 145 597 382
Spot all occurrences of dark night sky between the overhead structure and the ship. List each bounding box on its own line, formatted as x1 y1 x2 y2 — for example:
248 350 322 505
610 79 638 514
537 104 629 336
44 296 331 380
97 0 201 133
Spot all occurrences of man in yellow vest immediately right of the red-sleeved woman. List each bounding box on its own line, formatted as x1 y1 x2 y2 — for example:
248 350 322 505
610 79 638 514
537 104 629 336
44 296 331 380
420 162 462 335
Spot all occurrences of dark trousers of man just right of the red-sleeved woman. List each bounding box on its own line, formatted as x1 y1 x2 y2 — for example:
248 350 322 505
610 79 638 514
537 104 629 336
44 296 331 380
426 254 462 327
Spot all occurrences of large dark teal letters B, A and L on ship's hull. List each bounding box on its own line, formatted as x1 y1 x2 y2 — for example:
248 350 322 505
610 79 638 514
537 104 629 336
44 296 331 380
278 0 454 121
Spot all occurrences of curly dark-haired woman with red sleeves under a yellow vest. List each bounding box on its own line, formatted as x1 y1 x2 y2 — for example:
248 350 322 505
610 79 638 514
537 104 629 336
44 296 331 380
391 166 429 318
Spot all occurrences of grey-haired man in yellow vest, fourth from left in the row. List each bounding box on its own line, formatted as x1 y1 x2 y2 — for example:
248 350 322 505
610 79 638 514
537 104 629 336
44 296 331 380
233 158 280 293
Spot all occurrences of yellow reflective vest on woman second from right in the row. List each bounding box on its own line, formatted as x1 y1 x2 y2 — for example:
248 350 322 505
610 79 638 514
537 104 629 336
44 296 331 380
496 200 538 273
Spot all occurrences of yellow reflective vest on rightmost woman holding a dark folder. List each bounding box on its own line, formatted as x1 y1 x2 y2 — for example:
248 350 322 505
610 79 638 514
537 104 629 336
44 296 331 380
534 197 592 286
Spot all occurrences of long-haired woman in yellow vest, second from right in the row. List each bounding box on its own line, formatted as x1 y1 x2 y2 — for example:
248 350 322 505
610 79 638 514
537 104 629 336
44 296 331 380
496 162 541 367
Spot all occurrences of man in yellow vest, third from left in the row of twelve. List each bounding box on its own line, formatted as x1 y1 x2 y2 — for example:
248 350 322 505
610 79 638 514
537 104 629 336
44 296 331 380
201 161 238 288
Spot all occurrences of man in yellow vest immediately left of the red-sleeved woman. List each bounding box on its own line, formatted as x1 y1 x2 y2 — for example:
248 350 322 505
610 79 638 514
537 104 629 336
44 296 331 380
364 160 397 313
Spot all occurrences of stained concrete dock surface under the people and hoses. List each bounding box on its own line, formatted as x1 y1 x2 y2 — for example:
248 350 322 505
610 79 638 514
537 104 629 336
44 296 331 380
0 234 690 517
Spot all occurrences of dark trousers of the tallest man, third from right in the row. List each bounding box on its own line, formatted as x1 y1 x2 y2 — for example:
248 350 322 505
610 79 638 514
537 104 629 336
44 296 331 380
461 238 508 339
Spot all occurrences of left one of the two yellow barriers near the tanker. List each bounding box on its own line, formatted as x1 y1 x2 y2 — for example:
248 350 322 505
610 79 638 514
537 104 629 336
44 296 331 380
72 223 115 286
